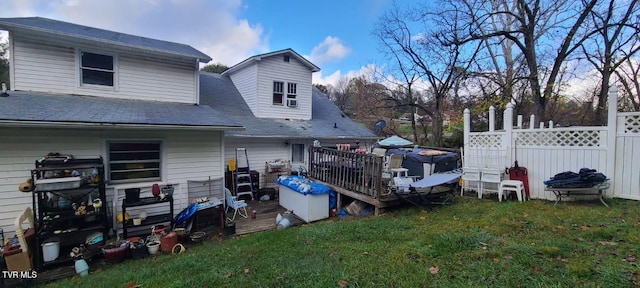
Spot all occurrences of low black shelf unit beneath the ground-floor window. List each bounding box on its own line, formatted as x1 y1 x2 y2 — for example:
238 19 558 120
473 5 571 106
122 196 173 239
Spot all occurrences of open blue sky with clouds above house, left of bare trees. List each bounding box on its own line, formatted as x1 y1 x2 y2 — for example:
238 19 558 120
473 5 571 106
0 0 420 84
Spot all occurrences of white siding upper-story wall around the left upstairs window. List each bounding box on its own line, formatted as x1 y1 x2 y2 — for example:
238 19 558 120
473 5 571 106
11 35 198 103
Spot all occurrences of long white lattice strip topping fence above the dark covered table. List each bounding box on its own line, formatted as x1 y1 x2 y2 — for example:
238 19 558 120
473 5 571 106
517 130 601 147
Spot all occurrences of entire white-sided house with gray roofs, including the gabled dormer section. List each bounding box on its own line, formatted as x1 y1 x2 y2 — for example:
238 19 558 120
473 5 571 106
0 17 377 236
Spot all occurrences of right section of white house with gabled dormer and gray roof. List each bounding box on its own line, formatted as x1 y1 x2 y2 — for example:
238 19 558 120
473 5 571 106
206 49 377 180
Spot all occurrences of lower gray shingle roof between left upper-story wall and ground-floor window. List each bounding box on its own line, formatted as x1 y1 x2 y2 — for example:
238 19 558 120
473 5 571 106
0 91 242 130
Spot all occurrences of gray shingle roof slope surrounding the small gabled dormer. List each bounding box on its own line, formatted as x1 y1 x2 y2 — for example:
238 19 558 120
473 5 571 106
200 72 378 139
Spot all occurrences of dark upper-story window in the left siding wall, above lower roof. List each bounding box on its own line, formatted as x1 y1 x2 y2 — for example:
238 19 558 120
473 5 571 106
80 52 115 87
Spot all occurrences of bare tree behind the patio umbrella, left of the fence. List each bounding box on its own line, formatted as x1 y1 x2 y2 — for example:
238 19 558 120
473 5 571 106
373 5 478 146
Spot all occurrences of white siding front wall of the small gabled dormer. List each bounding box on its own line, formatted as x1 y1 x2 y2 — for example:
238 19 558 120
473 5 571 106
254 55 312 120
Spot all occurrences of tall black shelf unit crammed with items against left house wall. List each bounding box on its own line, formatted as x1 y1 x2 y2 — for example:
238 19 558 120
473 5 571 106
31 157 110 271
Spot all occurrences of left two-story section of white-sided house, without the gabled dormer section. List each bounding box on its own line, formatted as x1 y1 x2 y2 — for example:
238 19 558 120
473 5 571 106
0 17 243 237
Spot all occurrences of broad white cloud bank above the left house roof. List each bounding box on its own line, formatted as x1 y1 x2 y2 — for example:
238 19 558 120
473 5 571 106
0 0 269 66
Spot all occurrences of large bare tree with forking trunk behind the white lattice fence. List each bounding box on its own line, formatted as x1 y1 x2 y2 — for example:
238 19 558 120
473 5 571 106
443 0 598 120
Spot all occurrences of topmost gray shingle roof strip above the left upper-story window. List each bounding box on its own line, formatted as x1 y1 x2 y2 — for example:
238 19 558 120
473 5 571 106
0 17 211 63
